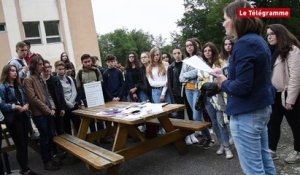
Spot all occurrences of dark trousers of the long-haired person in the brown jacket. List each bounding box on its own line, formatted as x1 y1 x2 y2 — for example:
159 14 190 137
32 116 55 163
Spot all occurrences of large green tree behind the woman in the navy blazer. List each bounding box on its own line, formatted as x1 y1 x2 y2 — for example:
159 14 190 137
171 0 300 49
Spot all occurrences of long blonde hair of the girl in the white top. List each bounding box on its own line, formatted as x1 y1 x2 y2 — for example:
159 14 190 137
147 47 167 79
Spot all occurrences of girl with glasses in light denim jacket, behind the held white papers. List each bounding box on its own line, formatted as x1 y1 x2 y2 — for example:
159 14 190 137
179 39 213 149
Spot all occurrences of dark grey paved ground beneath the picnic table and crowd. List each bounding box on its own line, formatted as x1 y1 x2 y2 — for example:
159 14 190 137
4 118 300 175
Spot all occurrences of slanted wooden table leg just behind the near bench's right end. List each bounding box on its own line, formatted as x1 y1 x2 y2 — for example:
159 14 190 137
112 123 129 152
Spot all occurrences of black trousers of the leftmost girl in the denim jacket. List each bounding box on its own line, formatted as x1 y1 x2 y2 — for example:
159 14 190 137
5 113 29 172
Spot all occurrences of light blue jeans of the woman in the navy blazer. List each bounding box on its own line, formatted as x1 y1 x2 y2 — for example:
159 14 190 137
230 106 276 175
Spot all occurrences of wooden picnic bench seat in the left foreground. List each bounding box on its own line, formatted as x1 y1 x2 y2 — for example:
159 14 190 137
53 134 124 175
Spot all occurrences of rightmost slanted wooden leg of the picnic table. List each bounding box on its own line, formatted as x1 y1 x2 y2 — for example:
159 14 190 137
158 116 187 154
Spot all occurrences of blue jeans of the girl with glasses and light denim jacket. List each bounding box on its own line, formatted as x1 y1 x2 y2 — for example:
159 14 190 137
185 89 211 140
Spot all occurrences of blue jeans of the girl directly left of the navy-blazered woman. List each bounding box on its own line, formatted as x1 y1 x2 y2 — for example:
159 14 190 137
205 98 229 147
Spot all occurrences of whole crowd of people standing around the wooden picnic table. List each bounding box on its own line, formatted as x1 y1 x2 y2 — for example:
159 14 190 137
0 1 300 175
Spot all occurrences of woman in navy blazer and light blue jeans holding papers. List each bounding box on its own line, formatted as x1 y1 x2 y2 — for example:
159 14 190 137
214 1 276 175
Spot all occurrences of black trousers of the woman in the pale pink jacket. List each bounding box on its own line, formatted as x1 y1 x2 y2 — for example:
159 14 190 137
268 93 300 151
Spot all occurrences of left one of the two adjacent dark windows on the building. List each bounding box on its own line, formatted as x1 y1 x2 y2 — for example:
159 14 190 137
23 21 42 44
